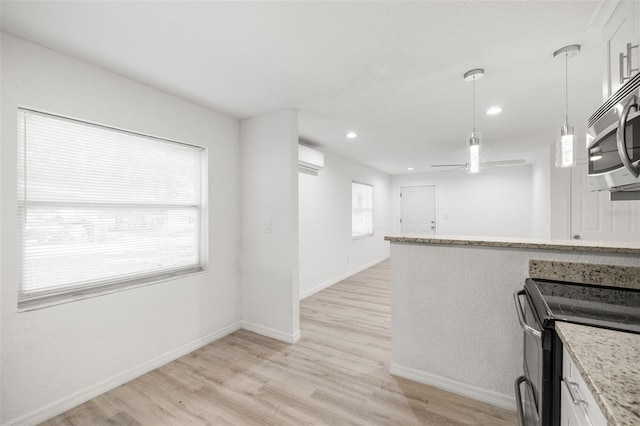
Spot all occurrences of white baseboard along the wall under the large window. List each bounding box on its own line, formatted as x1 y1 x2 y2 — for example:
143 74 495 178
4 321 241 426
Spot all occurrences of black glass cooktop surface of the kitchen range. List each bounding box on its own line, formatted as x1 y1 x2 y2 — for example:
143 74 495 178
525 280 640 333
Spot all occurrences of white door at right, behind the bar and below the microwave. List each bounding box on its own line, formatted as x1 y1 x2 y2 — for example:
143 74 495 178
571 165 640 242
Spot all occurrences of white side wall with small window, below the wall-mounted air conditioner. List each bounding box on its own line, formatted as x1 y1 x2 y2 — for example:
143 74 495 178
298 154 391 298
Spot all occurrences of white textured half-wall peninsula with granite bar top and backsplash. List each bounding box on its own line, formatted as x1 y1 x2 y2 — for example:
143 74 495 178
385 237 640 409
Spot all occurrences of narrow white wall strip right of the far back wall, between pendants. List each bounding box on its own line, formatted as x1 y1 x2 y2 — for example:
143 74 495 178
531 146 551 239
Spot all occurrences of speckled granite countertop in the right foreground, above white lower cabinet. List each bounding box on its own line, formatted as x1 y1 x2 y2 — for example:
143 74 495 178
556 321 640 426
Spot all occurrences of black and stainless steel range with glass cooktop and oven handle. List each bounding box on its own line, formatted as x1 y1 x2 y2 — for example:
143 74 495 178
514 278 640 426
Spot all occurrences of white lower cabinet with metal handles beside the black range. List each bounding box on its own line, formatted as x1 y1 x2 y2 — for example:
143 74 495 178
560 348 607 426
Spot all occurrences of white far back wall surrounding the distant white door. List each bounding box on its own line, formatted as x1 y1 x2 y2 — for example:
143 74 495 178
391 165 532 237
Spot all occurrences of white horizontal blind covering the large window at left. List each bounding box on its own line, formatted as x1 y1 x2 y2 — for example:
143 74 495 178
18 109 206 307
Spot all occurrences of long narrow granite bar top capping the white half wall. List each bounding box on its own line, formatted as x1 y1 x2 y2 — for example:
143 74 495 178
384 236 640 255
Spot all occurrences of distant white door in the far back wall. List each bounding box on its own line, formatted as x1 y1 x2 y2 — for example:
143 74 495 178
400 185 437 236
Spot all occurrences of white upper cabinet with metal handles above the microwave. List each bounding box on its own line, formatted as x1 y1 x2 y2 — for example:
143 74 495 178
602 0 640 100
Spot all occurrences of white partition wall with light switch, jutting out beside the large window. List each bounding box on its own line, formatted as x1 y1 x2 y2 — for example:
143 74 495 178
240 110 300 343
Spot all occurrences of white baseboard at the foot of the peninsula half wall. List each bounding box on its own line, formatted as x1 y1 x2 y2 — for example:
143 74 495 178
389 363 516 411
